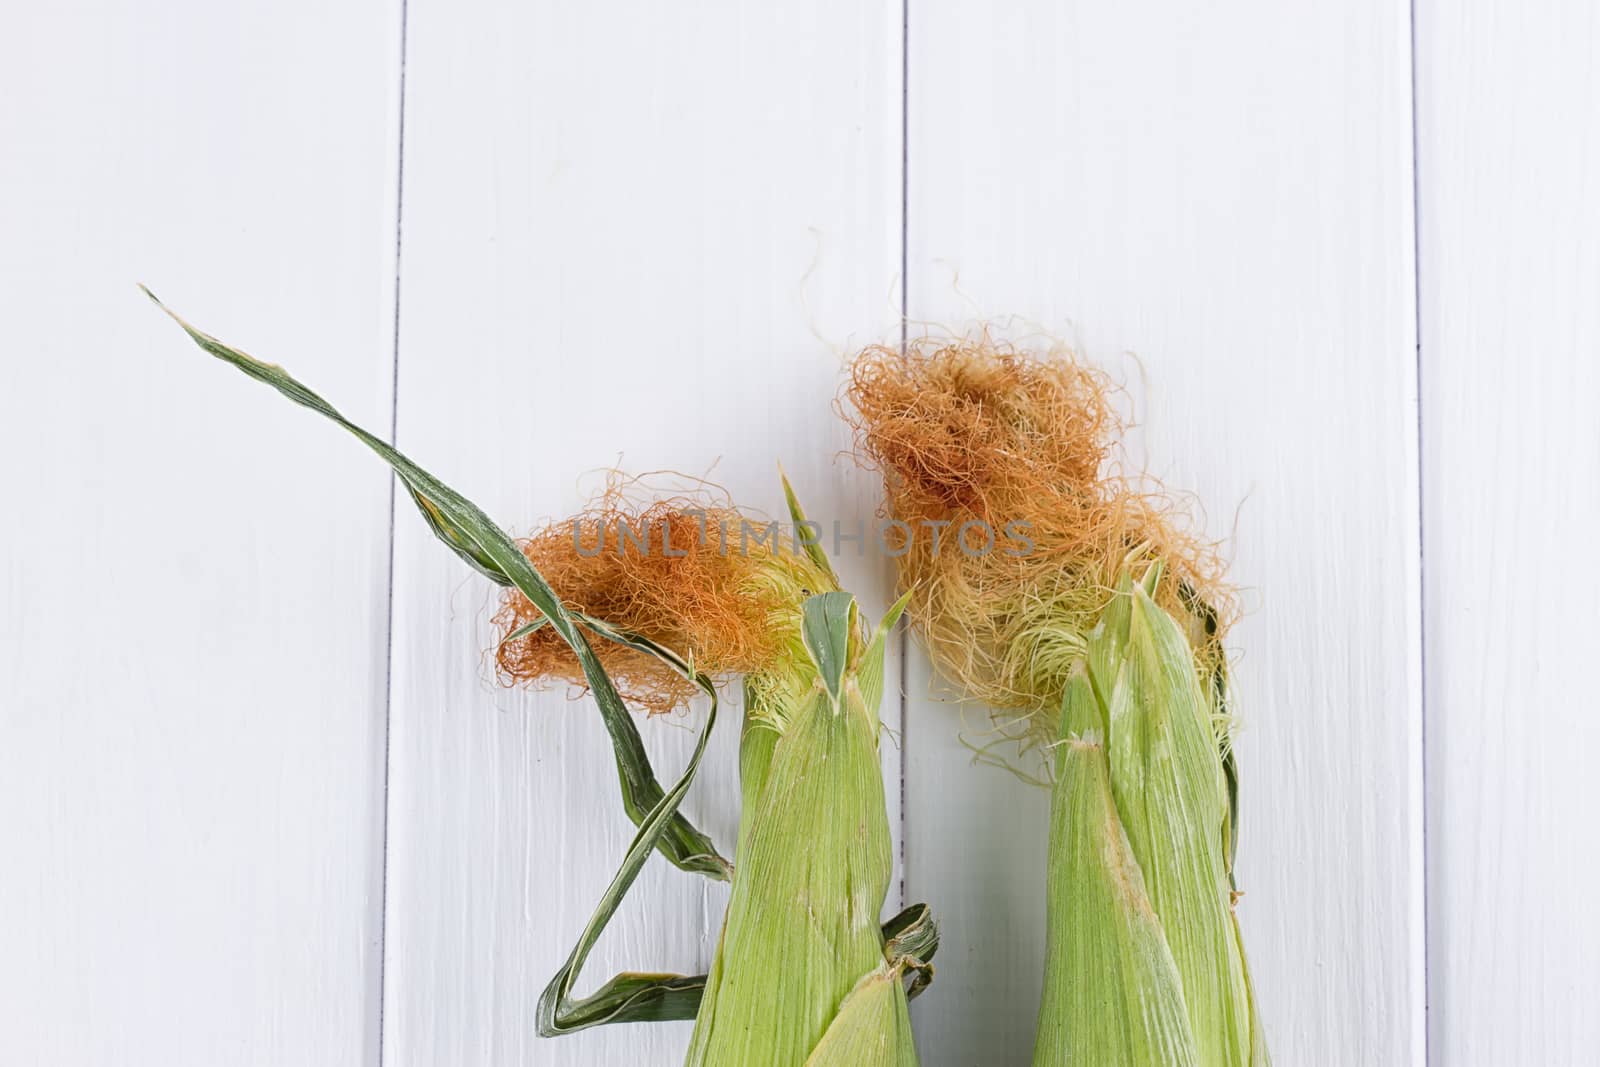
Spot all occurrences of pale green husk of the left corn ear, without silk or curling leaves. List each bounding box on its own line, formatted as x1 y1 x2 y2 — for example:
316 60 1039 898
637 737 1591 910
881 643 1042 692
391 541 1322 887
688 592 920 1065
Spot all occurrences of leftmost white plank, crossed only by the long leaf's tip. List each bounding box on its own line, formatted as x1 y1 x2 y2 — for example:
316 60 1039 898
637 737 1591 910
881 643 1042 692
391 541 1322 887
0 0 398 1067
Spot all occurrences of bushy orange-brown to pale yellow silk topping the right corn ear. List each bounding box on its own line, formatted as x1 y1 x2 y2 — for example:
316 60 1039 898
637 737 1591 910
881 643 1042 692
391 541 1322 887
842 333 1232 744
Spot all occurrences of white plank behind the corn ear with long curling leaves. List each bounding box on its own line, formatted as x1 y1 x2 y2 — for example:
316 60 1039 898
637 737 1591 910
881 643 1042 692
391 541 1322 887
384 0 899 1067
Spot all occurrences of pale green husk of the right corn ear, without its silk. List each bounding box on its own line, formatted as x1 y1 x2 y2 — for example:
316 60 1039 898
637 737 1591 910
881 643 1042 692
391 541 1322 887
1034 568 1266 1067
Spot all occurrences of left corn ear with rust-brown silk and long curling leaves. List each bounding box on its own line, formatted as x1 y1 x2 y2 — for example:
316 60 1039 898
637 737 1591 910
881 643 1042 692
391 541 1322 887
147 293 938 1067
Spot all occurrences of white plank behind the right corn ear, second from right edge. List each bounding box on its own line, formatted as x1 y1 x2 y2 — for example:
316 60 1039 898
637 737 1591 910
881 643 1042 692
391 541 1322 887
906 0 1422 1064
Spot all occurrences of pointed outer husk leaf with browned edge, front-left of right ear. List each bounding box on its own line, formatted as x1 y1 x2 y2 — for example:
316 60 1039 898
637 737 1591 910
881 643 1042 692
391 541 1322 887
1034 673 1203 1067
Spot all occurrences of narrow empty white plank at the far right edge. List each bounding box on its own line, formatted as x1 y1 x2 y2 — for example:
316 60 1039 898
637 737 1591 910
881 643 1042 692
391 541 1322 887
1418 2 1600 1067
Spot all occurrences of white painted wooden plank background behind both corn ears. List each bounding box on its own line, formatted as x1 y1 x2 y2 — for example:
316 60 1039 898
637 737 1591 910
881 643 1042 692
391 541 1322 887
0 0 1600 1067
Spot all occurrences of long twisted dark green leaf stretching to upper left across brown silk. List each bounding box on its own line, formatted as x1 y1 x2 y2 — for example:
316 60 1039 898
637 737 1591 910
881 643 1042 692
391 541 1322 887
139 285 730 880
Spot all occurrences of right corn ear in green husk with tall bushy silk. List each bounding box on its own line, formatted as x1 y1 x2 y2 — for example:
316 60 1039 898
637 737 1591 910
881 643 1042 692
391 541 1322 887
848 336 1267 1067
